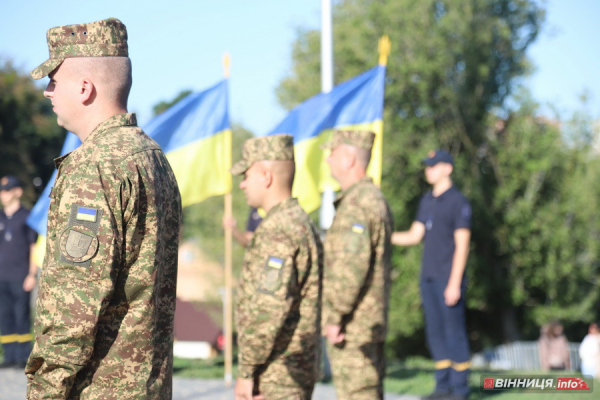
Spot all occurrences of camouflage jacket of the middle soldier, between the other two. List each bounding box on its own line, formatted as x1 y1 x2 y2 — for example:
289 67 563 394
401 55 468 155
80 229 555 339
236 198 323 387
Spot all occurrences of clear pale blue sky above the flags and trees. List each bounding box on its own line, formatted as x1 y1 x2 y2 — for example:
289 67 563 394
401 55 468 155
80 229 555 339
0 0 600 135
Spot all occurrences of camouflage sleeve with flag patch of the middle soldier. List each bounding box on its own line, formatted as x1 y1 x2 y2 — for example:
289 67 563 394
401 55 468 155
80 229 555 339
238 231 305 377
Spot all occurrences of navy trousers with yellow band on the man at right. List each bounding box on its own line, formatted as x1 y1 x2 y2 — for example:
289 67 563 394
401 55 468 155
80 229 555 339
421 279 471 396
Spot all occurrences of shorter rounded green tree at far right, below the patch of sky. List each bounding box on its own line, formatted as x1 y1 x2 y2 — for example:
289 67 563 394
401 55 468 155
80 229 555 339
488 100 600 339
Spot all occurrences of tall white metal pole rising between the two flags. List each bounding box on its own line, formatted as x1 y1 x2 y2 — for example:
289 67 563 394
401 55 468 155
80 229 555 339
319 0 335 230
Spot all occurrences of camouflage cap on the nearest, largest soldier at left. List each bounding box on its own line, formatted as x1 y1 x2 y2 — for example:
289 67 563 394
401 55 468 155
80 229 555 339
31 18 129 79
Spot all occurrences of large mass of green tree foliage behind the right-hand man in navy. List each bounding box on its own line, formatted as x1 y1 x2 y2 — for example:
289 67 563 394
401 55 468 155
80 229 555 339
277 0 600 356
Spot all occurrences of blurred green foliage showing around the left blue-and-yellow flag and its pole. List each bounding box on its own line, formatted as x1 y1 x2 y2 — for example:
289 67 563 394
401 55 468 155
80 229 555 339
153 90 253 271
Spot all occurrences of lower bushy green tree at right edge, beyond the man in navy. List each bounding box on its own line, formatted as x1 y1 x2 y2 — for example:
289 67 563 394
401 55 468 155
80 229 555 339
470 97 600 346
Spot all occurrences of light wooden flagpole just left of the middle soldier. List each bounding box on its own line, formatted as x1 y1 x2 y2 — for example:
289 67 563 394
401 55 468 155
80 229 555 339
223 54 233 386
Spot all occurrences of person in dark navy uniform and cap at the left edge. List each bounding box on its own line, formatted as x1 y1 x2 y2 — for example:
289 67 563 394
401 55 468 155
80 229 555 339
0 176 37 368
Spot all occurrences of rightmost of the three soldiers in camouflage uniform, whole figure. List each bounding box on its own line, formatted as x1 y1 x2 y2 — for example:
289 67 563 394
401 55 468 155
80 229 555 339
323 130 393 400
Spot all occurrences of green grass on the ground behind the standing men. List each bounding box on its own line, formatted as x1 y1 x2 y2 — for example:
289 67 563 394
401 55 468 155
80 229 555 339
174 356 600 400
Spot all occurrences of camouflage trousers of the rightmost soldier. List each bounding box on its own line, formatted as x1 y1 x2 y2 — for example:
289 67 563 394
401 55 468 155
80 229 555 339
327 342 385 400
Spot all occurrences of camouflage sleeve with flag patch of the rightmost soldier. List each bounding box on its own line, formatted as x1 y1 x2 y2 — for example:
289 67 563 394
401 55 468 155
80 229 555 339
323 208 372 325
